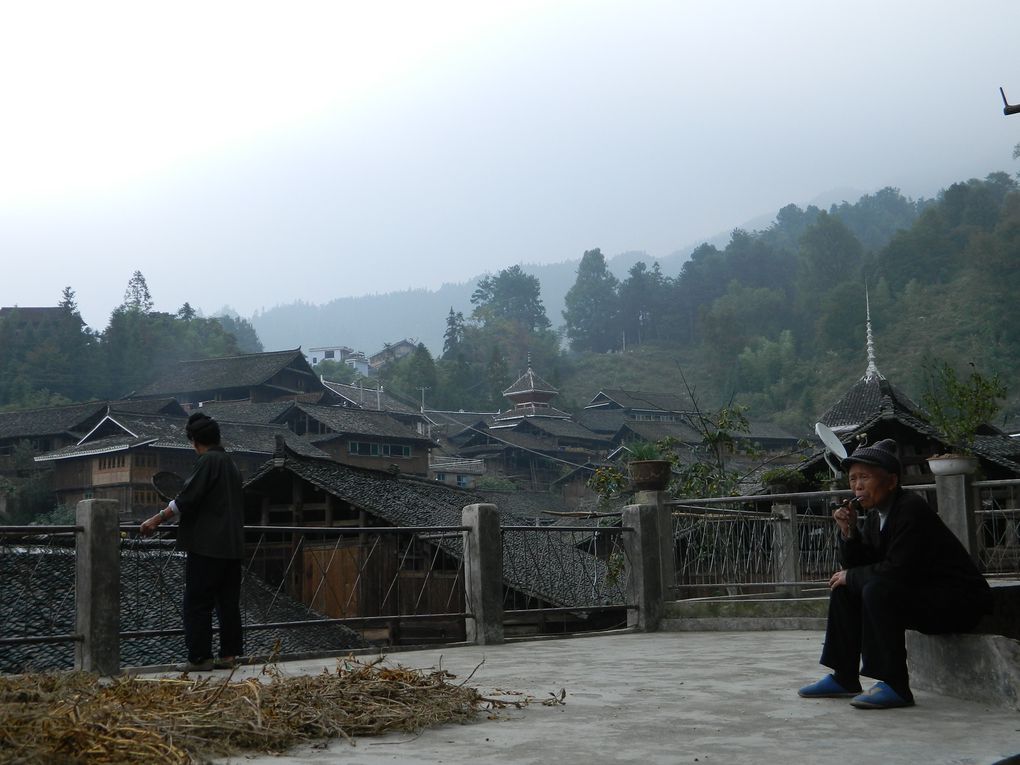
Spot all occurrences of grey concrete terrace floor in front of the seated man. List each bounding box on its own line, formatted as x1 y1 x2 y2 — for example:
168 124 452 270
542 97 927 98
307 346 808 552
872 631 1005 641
200 631 1020 765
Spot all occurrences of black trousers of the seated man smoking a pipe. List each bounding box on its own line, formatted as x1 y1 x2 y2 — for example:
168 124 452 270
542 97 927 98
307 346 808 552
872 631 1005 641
821 576 983 699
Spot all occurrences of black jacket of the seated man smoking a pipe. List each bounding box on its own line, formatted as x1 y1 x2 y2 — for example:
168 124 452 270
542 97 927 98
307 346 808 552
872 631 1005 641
839 489 991 607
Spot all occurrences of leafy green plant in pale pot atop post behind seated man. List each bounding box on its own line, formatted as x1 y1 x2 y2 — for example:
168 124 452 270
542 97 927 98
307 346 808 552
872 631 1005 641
921 361 1006 475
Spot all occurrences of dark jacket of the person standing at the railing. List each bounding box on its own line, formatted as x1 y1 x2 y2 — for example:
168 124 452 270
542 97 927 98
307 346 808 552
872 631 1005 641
174 446 245 560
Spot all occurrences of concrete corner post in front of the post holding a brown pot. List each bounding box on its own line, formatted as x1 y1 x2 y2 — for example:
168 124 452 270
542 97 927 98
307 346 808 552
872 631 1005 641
623 505 665 632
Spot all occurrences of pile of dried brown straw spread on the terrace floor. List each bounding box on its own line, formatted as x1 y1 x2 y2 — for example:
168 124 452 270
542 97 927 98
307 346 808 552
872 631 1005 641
0 659 510 765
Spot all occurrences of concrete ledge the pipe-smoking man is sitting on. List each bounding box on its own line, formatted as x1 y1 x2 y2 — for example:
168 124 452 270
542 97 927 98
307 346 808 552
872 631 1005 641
907 630 1020 710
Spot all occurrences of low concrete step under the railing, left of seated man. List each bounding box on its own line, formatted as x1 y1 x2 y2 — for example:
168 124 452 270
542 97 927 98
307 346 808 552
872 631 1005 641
659 598 828 632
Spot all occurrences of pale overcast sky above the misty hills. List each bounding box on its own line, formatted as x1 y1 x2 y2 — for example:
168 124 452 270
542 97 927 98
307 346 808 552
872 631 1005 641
0 0 1020 328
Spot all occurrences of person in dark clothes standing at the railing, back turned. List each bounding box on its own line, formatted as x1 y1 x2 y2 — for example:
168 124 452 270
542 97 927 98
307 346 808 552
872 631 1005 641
141 412 244 672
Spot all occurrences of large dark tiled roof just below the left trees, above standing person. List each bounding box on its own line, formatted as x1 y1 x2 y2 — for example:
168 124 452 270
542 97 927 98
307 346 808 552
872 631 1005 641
132 348 318 398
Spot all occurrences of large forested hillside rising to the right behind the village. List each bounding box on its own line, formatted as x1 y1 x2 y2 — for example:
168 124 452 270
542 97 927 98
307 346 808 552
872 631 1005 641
375 173 1020 432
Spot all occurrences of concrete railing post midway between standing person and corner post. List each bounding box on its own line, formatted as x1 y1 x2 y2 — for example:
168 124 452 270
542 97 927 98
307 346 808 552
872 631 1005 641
461 505 503 646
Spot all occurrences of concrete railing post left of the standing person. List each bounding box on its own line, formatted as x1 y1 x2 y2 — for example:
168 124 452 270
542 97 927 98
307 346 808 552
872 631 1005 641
74 500 120 675
